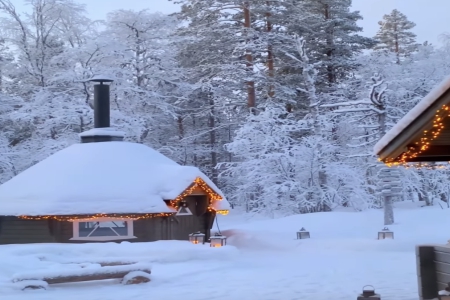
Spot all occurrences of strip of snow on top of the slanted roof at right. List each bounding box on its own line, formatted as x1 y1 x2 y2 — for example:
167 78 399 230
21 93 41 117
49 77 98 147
373 76 450 155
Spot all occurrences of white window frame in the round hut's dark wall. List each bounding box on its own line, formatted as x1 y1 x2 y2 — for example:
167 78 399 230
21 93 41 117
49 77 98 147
70 218 137 242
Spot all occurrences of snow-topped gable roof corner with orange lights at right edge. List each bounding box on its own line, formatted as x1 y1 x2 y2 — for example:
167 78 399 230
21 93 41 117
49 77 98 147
374 77 450 165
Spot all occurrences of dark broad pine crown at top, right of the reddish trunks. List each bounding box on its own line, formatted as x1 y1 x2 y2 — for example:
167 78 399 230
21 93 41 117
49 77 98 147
285 0 374 86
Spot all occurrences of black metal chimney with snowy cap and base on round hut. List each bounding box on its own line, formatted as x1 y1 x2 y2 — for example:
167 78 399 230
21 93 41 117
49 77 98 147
80 75 124 143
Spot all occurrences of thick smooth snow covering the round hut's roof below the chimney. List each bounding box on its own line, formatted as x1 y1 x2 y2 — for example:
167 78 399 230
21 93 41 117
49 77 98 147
0 142 229 216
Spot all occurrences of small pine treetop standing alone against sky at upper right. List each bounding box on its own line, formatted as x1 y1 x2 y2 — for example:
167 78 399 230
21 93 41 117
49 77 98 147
375 9 418 63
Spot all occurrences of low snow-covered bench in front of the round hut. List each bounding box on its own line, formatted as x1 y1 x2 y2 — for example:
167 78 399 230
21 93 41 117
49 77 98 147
12 263 151 289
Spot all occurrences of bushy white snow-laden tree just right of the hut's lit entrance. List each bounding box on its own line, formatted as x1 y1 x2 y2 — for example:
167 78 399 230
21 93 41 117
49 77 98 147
225 37 372 216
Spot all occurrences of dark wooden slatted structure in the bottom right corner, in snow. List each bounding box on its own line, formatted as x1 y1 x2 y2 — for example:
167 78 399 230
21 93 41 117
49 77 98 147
416 245 450 300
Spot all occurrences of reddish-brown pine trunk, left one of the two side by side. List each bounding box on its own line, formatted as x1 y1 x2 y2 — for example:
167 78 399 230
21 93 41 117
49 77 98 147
244 1 256 112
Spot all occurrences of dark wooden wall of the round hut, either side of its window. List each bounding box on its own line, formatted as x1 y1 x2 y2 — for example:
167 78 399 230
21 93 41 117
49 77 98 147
0 195 215 244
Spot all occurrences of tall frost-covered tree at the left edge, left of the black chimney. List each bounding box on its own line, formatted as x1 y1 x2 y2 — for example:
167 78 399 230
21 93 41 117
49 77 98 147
0 0 98 172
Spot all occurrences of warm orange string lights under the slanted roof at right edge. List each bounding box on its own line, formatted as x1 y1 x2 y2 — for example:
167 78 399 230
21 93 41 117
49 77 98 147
383 104 450 169
